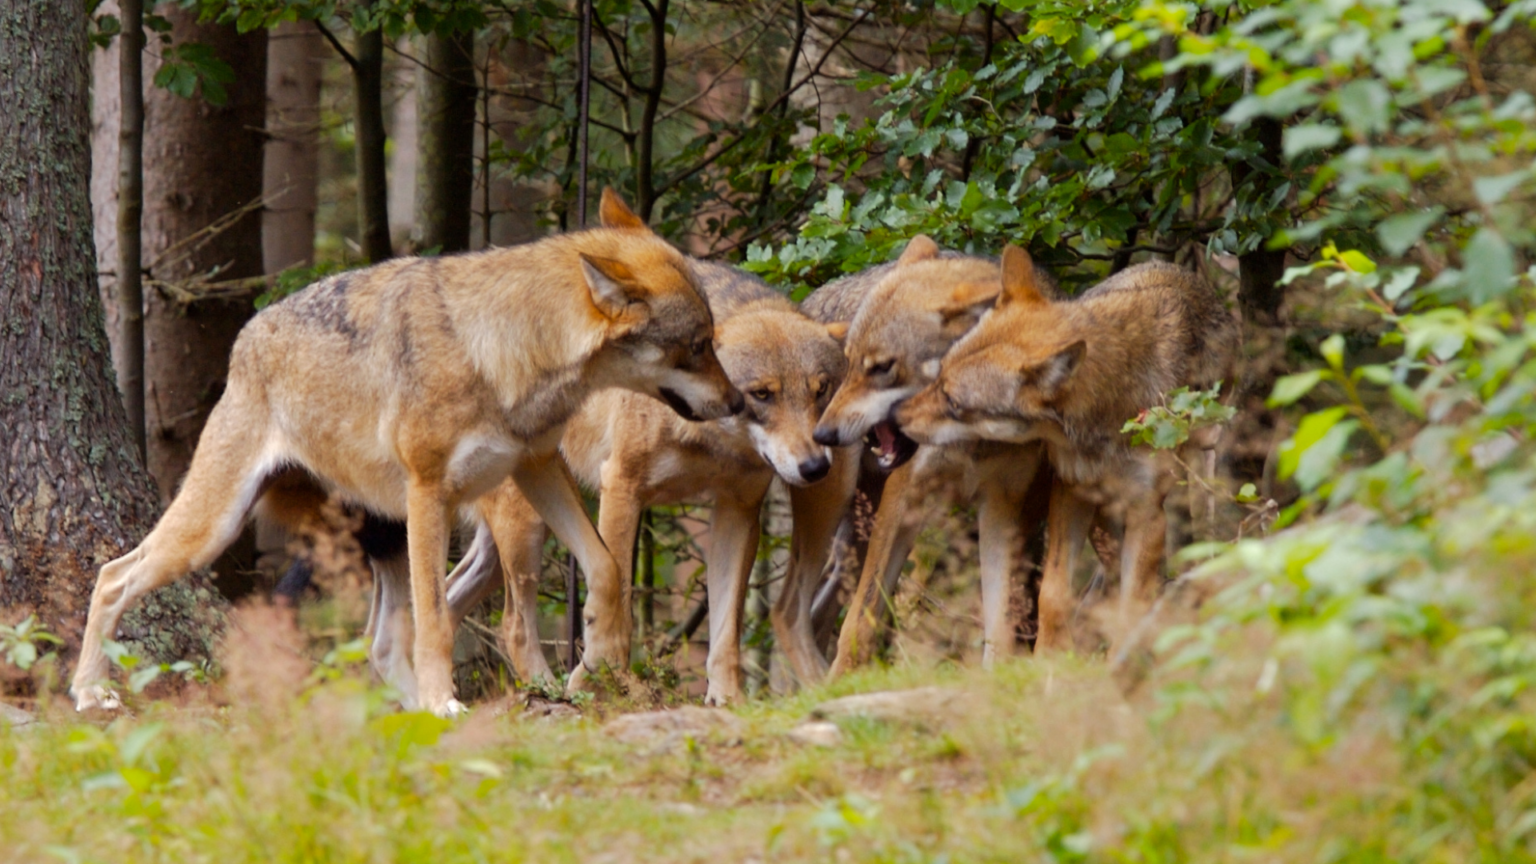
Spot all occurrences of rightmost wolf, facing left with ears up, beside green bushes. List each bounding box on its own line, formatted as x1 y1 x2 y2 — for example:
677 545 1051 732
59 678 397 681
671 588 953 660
895 246 1240 650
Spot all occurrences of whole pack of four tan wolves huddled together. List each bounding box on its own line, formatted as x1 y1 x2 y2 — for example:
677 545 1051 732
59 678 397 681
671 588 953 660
71 191 1240 716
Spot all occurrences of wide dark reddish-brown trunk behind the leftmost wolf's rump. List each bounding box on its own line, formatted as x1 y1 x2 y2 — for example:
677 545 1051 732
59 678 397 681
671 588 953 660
144 5 267 503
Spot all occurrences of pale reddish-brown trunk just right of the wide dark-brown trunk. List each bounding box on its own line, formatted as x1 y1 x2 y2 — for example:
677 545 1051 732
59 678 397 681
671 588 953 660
261 22 329 274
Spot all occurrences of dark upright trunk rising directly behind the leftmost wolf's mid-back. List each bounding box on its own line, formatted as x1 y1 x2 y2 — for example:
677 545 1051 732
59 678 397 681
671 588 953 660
416 34 479 252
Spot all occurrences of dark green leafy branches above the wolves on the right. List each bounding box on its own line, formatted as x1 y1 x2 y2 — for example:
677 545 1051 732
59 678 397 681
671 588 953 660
746 2 1290 284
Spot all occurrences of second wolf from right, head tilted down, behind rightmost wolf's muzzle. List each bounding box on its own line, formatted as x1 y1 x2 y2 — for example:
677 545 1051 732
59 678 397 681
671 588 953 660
805 235 1049 675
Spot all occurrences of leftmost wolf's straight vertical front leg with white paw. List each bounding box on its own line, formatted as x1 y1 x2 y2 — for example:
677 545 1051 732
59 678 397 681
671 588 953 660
406 478 468 716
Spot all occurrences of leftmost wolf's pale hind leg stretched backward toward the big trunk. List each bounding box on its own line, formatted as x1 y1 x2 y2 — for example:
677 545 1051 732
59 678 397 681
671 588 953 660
69 394 275 710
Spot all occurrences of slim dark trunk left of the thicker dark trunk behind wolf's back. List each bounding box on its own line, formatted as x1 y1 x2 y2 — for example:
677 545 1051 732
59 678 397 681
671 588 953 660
352 2 395 263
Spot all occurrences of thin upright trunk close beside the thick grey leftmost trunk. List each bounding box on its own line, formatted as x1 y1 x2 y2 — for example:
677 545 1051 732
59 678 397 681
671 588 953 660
117 0 147 460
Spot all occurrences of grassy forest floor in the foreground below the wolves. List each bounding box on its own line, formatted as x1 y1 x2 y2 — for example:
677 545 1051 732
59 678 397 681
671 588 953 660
0 578 1511 864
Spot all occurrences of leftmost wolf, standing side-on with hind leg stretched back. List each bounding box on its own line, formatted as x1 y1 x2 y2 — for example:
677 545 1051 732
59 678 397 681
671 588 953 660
71 189 743 715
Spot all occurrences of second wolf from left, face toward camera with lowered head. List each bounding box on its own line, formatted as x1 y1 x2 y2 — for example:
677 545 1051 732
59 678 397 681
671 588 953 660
375 261 857 704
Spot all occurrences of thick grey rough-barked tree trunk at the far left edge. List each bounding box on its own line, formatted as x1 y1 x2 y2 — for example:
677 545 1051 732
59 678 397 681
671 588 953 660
0 0 218 660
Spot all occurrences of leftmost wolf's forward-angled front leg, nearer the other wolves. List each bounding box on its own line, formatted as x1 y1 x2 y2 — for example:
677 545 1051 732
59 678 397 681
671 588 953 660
511 452 630 690
